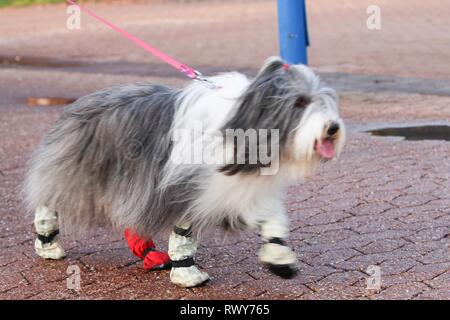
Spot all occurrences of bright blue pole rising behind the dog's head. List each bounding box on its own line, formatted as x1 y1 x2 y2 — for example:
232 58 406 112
278 0 309 64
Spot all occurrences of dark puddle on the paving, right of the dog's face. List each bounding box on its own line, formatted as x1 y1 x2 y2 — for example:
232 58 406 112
367 125 450 141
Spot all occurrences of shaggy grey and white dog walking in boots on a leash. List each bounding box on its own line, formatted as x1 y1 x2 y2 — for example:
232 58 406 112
25 58 345 287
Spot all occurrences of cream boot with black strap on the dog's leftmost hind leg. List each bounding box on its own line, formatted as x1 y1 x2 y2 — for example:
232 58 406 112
34 206 66 260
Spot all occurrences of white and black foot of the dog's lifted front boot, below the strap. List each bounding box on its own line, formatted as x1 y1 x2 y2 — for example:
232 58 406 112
259 243 297 279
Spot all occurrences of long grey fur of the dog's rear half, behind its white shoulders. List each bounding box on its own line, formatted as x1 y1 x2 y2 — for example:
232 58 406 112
24 85 192 236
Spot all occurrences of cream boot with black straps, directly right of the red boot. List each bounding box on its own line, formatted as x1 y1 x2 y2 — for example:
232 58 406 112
169 224 209 288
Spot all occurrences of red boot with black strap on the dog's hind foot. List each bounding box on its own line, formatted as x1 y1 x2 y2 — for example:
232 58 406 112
125 229 172 270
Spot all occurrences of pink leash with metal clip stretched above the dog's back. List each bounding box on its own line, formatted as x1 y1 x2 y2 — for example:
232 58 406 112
67 0 215 87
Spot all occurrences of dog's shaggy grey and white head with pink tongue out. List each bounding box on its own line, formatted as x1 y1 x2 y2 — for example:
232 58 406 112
221 57 345 178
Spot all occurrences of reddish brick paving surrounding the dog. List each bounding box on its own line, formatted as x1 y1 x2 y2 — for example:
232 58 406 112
0 0 450 299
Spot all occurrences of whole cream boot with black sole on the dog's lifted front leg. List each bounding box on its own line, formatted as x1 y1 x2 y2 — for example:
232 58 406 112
259 215 297 279
